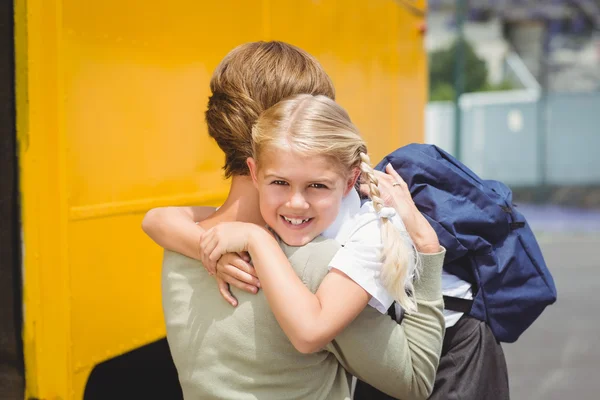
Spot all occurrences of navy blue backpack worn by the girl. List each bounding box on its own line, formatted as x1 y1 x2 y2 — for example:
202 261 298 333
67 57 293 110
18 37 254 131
376 144 556 343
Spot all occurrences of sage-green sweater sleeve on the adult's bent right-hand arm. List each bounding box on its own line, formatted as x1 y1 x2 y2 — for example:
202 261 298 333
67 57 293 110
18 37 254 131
327 248 446 400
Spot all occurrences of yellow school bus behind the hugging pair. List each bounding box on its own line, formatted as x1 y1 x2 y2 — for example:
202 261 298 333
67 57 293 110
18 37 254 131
0 0 426 400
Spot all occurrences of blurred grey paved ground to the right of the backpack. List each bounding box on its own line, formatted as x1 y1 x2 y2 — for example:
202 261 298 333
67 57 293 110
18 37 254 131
504 206 600 400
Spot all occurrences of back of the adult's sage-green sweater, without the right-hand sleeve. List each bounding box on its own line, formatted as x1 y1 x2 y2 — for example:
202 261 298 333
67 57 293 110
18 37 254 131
162 238 350 400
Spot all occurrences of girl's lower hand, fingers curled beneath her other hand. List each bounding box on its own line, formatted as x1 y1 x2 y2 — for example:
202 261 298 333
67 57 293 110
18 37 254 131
215 253 260 307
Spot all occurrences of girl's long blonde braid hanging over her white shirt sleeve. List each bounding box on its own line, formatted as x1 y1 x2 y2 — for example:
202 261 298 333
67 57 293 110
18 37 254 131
360 152 417 313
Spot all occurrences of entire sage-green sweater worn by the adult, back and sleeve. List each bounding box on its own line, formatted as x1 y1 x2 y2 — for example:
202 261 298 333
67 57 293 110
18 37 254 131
162 238 444 400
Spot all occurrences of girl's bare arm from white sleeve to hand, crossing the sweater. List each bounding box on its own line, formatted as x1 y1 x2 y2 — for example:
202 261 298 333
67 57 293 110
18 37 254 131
201 222 370 353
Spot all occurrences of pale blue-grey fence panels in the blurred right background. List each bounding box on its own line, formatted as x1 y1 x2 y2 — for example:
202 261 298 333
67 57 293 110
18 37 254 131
425 90 600 186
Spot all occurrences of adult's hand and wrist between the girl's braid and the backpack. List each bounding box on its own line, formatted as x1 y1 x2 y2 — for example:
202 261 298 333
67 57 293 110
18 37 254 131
361 164 440 253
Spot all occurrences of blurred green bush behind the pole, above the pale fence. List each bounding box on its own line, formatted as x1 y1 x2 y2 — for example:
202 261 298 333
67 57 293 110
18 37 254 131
429 41 513 101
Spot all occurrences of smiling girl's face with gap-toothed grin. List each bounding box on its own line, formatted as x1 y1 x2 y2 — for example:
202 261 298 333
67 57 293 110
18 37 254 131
248 150 358 246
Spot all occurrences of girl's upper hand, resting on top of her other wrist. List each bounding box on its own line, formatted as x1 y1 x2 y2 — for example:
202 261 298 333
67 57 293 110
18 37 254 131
198 222 256 275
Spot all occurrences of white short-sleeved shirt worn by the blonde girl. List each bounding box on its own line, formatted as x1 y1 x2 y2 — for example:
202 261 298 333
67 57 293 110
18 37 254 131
323 190 473 328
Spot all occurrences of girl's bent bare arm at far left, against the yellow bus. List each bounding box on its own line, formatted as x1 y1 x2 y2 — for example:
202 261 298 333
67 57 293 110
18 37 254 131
142 207 215 260
